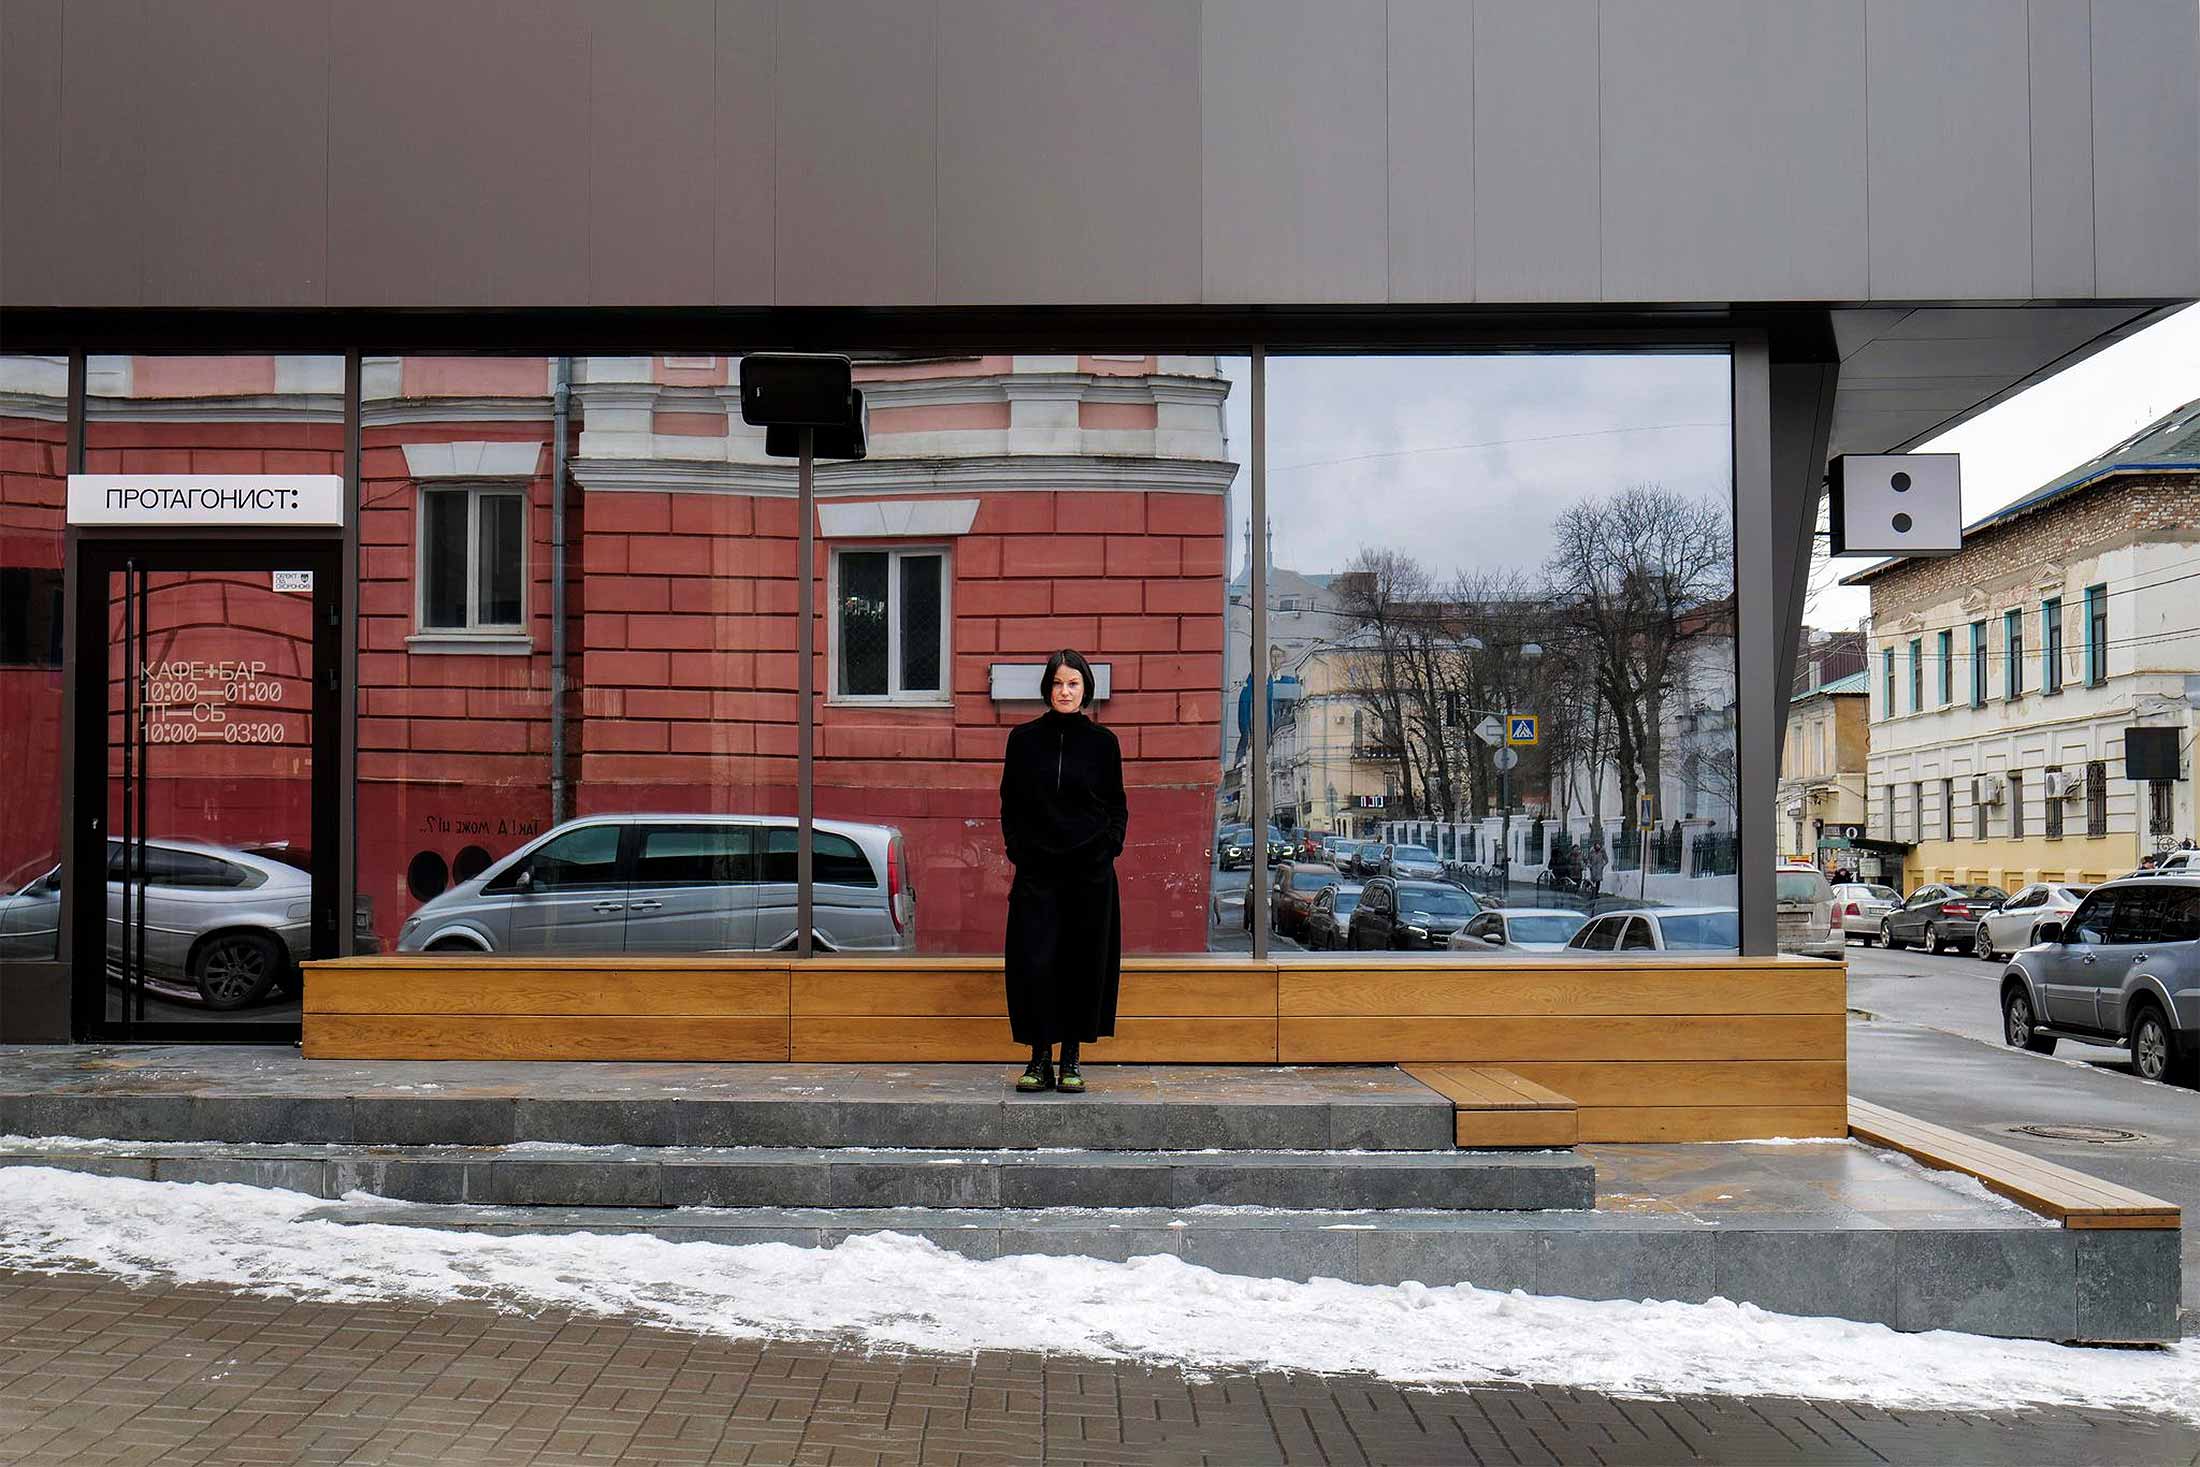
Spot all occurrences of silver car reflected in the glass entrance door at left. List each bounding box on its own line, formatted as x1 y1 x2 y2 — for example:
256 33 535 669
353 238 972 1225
0 840 312 1012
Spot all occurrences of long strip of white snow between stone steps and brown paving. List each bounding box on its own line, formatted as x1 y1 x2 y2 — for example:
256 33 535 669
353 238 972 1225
0 1168 2200 1421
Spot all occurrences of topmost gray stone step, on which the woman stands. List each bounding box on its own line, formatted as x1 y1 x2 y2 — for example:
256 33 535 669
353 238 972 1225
0 1047 1452 1150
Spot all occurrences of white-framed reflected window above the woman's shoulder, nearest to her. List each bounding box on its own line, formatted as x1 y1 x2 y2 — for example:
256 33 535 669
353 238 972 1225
829 545 950 704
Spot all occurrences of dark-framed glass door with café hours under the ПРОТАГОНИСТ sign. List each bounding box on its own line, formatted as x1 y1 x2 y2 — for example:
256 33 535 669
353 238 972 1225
64 543 337 1040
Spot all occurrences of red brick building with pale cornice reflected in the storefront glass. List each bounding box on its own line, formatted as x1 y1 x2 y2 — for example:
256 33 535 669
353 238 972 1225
0 354 1236 952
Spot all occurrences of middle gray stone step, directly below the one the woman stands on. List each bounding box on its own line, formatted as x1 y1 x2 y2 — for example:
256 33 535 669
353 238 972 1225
0 1139 1595 1212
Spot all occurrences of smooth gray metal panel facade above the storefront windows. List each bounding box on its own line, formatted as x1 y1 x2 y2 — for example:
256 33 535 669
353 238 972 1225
0 0 2200 306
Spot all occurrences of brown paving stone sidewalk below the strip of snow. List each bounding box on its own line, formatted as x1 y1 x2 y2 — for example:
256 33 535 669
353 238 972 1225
0 1271 2200 1467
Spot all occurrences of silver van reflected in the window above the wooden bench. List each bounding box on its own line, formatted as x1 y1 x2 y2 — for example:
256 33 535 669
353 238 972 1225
398 814 917 955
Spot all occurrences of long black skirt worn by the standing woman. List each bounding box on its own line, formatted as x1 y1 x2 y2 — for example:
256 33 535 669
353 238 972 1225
1005 864 1122 1045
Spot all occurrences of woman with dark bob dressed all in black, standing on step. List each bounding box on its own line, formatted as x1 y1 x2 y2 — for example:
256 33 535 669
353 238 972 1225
1001 647 1131 1095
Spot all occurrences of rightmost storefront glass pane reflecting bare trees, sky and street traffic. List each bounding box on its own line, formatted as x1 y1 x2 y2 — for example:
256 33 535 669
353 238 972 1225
1258 354 1738 959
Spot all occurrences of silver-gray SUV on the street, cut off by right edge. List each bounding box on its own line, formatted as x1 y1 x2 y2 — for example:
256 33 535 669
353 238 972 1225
2002 873 2200 1084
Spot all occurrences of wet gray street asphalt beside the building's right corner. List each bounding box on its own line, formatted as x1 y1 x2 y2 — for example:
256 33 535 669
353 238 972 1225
1848 944 2200 1335
